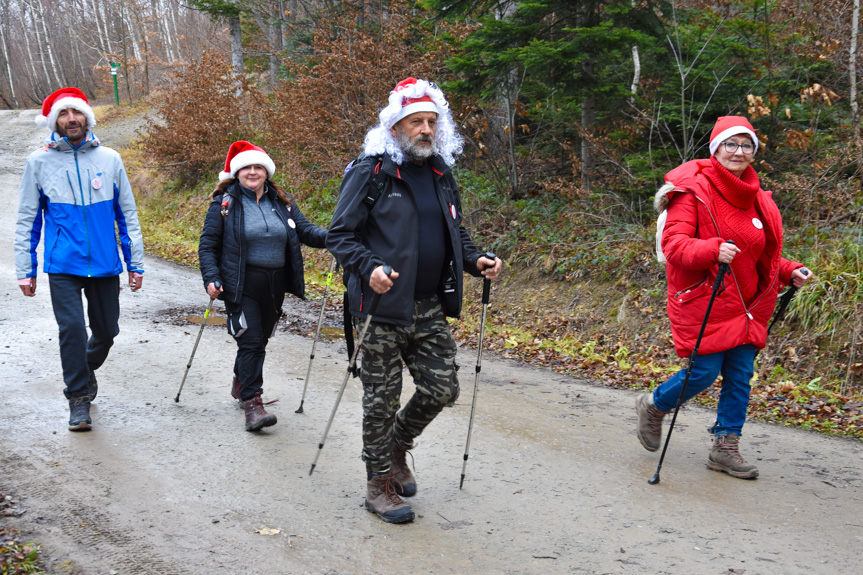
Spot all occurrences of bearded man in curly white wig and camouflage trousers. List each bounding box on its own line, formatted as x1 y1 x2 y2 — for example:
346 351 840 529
327 78 501 523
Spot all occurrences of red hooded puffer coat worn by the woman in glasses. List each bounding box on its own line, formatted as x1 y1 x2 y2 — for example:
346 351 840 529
654 160 803 357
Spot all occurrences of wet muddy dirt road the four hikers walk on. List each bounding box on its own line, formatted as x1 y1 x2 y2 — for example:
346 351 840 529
0 111 863 575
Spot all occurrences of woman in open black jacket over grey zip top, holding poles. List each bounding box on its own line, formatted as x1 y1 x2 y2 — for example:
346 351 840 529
198 141 327 431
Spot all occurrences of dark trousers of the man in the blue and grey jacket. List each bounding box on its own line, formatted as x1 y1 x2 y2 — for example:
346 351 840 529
48 274 120 399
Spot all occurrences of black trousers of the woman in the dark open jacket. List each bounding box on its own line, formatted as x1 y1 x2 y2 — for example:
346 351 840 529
228 266 288 401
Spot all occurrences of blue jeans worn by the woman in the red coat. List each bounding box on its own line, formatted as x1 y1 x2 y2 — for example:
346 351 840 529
653 344 758 435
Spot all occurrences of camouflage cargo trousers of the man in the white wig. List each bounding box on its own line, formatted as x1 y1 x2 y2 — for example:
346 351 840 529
354 297 458 473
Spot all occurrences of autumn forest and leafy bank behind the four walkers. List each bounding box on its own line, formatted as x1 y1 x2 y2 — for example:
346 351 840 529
0 0 863 436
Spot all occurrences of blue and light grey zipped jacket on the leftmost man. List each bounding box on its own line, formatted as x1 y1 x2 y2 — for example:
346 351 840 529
15 132 144 279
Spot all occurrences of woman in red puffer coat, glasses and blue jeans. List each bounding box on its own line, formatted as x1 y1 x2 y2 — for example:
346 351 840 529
636 116 812 479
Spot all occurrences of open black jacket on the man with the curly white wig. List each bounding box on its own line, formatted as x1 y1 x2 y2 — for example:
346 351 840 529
327 155 482 326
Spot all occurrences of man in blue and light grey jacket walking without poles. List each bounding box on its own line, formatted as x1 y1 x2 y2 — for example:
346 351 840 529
15 88 144 431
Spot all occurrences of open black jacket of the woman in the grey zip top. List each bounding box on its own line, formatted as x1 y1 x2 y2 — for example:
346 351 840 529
198 182 327 303
